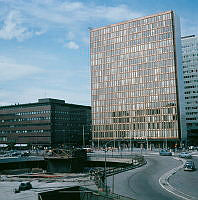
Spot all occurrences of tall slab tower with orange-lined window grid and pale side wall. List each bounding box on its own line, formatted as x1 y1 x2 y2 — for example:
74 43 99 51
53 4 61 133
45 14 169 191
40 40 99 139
90 11 186 148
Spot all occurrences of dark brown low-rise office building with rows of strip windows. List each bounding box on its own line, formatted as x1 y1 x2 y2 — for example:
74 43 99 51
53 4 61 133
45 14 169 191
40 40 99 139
0 98 91 146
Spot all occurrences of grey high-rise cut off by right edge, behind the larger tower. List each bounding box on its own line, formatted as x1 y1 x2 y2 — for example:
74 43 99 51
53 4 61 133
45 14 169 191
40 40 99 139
182 35 198 145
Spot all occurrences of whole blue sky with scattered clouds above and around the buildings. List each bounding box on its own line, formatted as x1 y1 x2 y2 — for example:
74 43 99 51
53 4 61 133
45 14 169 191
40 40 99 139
0 0 198 106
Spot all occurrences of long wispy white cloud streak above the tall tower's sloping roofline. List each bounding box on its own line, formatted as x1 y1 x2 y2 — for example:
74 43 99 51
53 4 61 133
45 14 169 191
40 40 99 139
54 1 141 23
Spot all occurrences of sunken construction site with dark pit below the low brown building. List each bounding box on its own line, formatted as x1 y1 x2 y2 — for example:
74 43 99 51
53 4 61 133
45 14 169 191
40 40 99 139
0 149 145 200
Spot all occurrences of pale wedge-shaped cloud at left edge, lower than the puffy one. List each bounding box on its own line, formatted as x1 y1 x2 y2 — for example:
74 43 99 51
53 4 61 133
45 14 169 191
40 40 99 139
0 57 42 82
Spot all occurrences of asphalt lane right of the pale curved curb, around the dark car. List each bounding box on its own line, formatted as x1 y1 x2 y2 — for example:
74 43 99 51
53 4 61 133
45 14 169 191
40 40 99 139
169 153 198 199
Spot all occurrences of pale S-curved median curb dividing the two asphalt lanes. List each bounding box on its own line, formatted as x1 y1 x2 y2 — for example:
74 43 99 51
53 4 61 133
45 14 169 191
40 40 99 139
159 157 198 200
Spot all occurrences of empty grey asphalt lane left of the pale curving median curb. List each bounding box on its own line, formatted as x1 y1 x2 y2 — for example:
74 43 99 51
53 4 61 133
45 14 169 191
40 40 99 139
107 154 185 200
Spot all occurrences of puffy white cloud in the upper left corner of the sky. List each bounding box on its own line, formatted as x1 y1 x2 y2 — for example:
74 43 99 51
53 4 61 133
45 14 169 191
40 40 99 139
0 11 31 41
